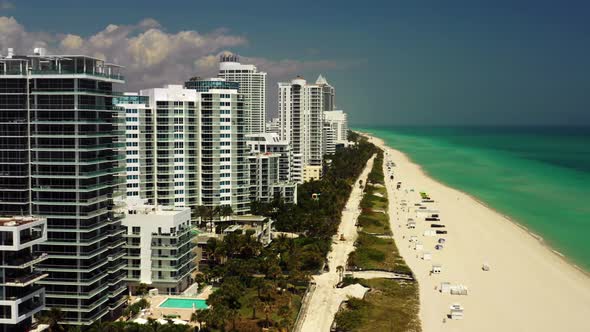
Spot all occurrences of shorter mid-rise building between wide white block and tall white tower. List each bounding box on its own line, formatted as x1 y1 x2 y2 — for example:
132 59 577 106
246 133 297 203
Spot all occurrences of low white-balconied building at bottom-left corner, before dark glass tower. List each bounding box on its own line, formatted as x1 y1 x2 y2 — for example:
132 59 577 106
0 217 47 332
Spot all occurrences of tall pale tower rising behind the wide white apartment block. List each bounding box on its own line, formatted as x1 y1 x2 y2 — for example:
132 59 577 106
218 54 266 134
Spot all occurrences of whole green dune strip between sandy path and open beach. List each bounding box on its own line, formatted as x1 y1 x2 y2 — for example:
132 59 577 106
336 151 421 332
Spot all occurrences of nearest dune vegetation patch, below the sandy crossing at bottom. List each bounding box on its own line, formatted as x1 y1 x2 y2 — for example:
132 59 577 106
336 279 422 332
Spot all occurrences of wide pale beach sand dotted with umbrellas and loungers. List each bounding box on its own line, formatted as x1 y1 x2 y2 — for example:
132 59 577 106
371 134 590 332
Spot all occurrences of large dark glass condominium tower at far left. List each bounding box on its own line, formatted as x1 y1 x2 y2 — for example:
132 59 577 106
0 49 126 325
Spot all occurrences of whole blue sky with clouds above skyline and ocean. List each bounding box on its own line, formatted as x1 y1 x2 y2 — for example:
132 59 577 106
0 0 590 126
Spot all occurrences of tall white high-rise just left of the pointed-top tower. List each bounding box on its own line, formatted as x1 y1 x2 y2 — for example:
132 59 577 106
278 77 325 183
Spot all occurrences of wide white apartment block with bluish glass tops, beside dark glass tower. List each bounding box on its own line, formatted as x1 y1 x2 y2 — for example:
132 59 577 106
117 78 249 220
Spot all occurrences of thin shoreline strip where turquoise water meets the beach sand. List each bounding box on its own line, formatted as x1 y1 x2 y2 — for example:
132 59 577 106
354 130 590 278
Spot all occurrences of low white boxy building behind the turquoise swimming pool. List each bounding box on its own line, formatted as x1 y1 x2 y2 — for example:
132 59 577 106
122 200 196 294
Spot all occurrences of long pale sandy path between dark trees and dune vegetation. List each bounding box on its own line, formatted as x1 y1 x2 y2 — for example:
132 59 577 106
300 157 375 332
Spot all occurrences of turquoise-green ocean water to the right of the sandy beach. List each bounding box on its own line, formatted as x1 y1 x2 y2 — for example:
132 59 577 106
358 127 590 271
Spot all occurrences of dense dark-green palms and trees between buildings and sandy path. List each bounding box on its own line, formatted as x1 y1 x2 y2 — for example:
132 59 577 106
192 134 377 331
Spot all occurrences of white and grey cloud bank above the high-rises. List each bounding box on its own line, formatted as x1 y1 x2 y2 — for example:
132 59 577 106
0 16 360 111
